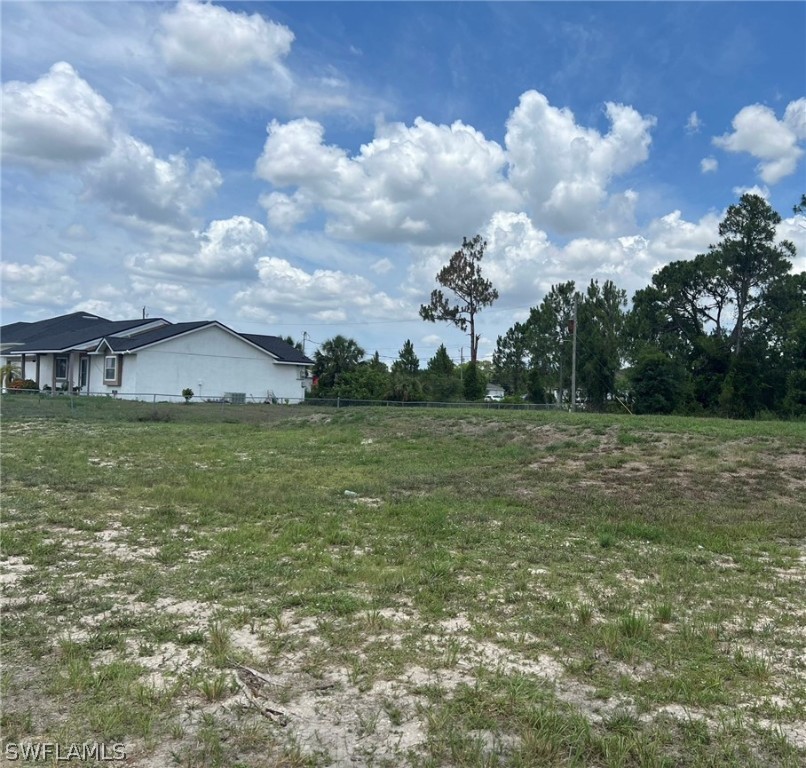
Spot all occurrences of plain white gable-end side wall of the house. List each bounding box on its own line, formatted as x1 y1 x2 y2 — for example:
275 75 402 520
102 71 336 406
103 327 304 401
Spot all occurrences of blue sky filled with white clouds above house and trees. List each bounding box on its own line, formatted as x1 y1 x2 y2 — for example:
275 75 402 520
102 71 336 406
0 1 806 362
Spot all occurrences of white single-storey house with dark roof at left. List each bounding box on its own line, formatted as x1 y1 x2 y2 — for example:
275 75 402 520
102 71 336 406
0 312 313 401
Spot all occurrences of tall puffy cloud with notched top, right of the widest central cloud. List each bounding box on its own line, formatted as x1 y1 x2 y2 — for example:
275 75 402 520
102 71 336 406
506 91 655 232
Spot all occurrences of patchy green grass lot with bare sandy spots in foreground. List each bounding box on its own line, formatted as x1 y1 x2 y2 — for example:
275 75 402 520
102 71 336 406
0 396 806 768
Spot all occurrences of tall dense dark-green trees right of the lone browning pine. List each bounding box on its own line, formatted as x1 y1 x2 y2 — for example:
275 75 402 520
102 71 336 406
493 194 806 418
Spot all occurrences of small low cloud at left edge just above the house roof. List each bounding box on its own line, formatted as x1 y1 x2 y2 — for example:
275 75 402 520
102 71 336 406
0 253 81 307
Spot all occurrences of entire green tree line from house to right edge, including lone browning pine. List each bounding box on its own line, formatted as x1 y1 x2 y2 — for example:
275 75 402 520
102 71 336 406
311 194 806 418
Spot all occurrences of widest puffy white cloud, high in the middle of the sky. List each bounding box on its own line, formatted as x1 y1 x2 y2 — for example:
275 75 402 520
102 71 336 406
256 118 519 243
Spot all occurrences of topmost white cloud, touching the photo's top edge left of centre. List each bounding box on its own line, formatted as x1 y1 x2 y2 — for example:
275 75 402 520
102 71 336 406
157 0 294 76
